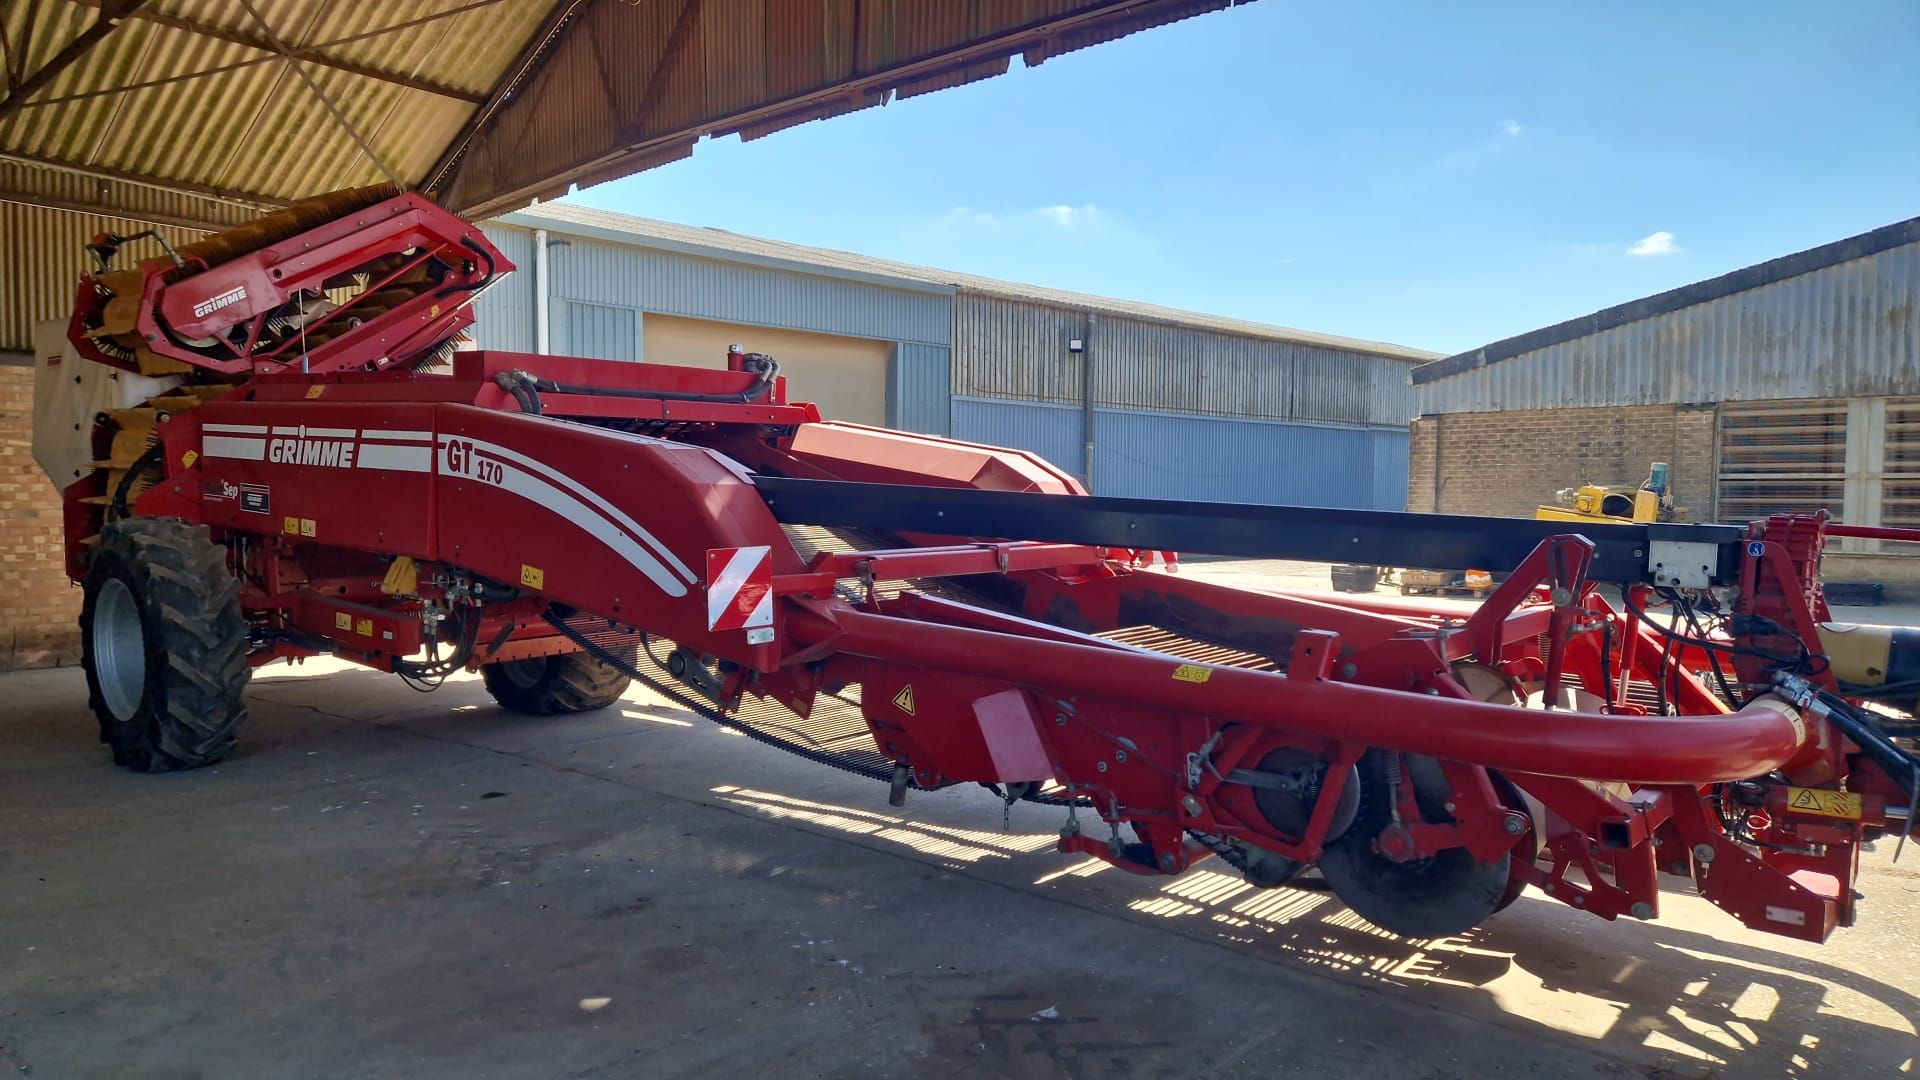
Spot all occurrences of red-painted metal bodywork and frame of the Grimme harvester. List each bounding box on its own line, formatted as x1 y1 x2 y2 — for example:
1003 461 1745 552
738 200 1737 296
65 189 1884 940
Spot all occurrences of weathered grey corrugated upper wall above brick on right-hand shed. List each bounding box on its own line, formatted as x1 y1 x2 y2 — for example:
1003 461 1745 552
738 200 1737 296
1415 244 1920 415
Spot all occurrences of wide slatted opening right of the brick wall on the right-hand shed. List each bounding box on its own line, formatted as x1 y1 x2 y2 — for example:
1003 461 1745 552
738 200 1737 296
1720 400 1843 523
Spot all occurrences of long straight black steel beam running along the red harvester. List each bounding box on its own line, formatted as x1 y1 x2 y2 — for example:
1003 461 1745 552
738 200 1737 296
755 477 1745 582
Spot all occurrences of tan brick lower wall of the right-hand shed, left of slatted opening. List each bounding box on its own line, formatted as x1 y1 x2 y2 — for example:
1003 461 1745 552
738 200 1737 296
1407 405 1716 521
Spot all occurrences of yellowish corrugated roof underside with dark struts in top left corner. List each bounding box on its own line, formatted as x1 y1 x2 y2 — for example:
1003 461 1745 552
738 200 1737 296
0 0 553 204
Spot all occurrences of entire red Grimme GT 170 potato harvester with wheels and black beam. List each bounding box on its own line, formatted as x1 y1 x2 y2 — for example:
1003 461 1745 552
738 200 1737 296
36 188 1920 940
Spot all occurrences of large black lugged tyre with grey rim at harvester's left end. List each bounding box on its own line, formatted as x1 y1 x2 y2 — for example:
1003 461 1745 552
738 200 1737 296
81 517 253 773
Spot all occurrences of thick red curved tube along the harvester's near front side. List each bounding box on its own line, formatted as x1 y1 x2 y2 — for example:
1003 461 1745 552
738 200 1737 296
787 603 1809 784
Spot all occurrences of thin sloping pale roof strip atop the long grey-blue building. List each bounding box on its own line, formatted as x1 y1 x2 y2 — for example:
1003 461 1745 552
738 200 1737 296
497 202 1440 363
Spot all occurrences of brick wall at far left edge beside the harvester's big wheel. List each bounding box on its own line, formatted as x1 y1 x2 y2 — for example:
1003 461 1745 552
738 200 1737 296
0 365 81 671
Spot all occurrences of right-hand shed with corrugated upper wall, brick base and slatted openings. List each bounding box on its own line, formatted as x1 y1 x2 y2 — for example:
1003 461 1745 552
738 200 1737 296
1407 217 1920 582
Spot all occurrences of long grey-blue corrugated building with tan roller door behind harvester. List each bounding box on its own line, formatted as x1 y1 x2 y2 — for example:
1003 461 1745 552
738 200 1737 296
476 204 1438 509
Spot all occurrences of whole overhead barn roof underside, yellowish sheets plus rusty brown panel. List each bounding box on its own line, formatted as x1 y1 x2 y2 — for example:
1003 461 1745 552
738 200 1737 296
0 0 1244 227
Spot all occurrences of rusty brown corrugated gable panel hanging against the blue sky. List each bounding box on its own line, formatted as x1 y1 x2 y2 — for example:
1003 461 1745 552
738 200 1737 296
430 0 1259 215
